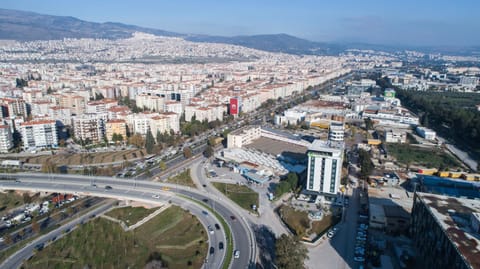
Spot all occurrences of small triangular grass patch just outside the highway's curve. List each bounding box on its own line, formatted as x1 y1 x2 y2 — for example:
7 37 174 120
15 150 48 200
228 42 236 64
212 182 259 212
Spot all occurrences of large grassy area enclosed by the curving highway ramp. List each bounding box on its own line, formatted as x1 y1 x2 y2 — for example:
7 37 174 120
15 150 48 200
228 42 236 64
23 206 208 269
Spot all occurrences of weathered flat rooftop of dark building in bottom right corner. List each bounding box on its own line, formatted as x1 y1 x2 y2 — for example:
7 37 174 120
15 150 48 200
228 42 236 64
417 192 480 268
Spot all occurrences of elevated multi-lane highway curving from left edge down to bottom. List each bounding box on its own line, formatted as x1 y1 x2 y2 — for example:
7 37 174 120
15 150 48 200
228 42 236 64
0 174 254 268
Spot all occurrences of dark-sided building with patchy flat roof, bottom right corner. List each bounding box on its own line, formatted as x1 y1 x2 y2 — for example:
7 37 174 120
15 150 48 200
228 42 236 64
411 192 480 269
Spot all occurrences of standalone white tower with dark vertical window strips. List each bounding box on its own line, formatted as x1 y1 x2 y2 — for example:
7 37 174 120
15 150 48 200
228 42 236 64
306 140 343 200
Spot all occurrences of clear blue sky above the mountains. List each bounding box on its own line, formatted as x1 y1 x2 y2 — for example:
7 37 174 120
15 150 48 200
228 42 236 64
0 0 480 46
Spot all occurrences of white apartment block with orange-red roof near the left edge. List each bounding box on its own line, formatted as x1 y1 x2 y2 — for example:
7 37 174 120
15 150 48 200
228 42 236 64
18 120 58 150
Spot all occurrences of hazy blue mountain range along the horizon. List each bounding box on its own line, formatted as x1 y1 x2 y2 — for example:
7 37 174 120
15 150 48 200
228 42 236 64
0 9 479 55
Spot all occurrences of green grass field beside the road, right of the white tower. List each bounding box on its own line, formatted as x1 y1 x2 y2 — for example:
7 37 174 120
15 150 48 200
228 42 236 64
387 144 460 170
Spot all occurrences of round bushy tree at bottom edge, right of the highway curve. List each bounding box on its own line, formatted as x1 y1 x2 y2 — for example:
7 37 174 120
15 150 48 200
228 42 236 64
275 234 308 269
